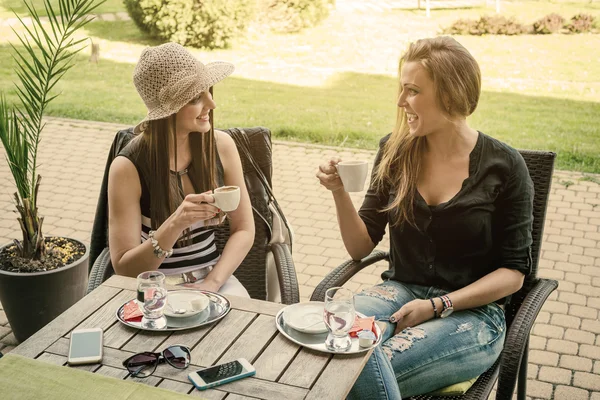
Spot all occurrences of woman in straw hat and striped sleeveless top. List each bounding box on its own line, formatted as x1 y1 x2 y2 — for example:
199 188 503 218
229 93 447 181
108 43 254 297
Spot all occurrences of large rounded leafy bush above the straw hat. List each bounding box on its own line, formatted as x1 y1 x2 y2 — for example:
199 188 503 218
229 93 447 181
124 0 255 49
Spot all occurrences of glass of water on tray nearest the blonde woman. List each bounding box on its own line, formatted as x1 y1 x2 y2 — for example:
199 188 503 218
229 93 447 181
323 287 356 352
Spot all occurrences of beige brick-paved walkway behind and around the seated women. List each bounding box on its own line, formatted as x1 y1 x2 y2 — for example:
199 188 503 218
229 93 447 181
0 119 600 400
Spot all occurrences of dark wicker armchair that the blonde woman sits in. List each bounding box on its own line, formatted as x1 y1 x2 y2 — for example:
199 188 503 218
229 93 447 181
311 150 558 400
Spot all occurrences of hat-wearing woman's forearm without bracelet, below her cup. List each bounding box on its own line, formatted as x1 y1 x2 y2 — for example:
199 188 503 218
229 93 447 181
206 229 254 287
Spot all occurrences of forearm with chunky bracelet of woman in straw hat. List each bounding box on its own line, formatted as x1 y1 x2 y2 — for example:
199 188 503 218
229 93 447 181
114 216 183 278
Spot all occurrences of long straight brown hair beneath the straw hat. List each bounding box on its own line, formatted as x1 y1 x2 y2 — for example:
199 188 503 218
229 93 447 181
136 88 217 239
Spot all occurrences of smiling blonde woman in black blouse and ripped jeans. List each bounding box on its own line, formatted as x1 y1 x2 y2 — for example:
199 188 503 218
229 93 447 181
317 37 533 399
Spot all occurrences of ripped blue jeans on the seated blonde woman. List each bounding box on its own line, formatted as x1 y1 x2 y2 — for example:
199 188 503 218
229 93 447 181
348 280 506 400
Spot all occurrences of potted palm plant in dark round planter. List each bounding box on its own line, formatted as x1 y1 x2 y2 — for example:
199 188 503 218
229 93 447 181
0 0 101 341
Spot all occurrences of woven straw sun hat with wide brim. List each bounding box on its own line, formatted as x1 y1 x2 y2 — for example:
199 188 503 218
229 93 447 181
133 43 234 133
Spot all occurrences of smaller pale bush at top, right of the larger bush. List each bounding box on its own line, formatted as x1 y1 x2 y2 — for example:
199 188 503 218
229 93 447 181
252 0 335 33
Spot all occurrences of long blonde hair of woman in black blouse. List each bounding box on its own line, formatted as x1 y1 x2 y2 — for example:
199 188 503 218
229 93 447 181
374 36 481 226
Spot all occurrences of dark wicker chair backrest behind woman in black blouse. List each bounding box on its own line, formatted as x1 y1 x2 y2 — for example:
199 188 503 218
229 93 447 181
505 150 556 326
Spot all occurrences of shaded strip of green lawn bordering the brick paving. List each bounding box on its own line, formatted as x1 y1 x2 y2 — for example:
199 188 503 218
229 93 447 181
0 46 600 173
